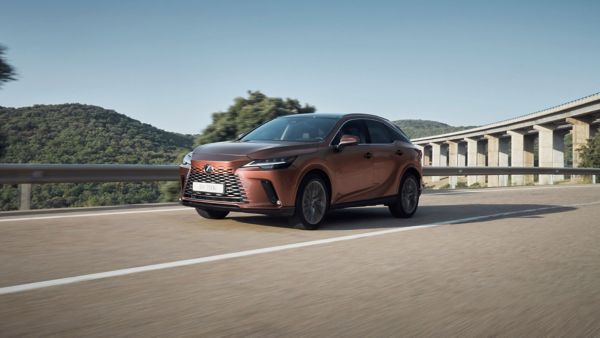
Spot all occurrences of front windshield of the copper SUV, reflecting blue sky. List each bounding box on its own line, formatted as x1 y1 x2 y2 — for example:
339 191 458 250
240 115 338 142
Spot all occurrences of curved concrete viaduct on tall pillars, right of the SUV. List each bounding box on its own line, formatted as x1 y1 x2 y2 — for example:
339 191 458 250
412 93 600 187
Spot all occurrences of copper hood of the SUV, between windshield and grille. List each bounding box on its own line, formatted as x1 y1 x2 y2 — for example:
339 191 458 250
192 141 319 161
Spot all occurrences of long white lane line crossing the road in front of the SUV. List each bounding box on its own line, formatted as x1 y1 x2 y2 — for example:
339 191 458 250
0 201 600 295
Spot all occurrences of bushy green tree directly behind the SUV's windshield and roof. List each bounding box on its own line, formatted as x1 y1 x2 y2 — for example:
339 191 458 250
196 91 316 144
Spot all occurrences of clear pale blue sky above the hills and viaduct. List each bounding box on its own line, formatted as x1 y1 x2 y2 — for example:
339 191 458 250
0 0 600 133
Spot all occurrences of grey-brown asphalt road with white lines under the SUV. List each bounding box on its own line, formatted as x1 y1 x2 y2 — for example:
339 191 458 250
0 185 600 337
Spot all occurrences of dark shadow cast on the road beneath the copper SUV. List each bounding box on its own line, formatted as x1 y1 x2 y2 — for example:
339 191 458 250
228 204 576 231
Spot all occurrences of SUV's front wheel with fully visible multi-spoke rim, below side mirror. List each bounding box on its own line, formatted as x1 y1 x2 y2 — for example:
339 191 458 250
290 175 330 230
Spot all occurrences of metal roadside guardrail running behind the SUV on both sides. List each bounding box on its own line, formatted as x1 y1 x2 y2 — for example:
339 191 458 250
0 164 600 210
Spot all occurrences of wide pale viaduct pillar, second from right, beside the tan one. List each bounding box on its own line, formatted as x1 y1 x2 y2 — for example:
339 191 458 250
533 125 565 184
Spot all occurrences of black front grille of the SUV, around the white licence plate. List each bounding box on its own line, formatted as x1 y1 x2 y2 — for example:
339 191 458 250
183 167 248 203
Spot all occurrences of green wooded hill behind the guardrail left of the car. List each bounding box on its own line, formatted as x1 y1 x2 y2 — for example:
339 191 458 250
0 104 193 210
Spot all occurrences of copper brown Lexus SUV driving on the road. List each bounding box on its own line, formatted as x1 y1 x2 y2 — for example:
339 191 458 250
180 113 422 229
